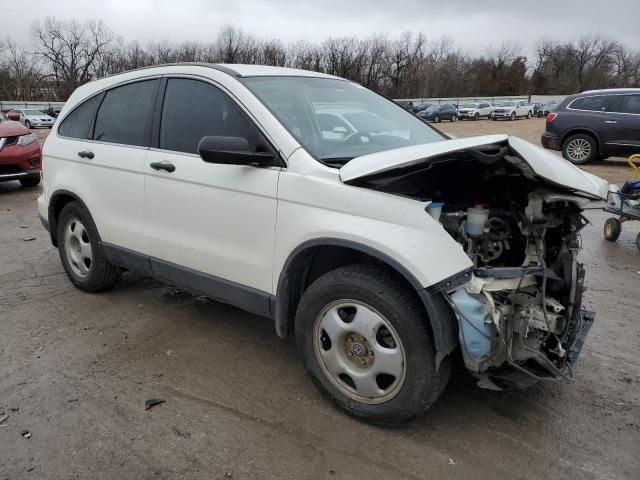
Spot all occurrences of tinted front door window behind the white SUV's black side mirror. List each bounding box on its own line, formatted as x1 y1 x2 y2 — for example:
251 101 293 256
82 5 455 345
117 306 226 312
160 78 259 153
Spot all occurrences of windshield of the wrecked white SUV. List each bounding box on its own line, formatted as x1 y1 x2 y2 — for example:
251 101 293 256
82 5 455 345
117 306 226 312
242 77 445 166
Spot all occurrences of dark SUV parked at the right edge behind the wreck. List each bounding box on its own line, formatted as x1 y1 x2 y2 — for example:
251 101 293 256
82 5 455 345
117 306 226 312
542 88 640 165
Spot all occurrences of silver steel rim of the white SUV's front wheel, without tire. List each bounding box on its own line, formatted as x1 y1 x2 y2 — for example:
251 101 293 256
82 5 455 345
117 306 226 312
313 300 406 404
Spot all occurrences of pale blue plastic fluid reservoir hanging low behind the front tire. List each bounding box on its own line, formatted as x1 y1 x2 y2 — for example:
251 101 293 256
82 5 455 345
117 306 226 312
451 288 493 361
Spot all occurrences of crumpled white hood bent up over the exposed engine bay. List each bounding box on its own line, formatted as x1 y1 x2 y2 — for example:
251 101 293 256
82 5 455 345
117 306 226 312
340 135 609 200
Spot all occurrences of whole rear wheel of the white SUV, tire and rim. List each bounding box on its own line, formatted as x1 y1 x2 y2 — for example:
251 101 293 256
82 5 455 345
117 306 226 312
57 202 118 292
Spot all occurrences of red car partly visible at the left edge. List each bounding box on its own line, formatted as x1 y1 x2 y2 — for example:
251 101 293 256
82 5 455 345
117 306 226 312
0 112 42 187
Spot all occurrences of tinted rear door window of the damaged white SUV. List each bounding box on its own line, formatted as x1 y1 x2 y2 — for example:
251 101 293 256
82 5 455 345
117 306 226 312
93 80 159 146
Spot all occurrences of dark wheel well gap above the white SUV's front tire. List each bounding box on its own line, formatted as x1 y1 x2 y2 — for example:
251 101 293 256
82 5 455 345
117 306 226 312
274 245 418 338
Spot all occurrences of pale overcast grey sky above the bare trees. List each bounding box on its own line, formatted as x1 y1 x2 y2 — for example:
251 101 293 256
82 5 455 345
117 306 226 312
0 0 640 52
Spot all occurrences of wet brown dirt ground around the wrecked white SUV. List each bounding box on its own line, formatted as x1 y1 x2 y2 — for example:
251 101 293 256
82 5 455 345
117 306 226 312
0 120 640 480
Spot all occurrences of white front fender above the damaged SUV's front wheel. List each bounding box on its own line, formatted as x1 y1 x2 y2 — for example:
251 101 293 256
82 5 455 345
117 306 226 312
274 149 472 291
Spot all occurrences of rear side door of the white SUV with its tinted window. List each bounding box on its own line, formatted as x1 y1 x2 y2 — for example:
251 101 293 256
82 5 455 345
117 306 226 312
70 79 160 253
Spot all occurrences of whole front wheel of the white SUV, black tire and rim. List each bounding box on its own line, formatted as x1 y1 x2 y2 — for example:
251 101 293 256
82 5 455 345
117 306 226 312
295 265 450 425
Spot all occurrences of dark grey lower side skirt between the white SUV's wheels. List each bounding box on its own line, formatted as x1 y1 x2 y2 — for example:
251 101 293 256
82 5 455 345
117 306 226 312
102 242 273 318
